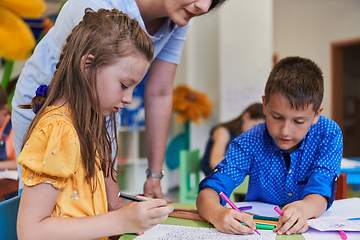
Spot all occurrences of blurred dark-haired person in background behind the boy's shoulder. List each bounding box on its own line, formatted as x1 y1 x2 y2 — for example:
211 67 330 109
201 103 265 175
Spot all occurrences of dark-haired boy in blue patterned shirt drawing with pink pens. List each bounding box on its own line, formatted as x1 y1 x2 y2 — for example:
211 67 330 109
196 57 343 235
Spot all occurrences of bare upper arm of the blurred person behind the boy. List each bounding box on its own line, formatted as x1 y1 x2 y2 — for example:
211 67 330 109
209 127 230 169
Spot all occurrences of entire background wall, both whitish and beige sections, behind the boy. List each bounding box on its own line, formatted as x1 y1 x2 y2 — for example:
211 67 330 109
169 0 360 188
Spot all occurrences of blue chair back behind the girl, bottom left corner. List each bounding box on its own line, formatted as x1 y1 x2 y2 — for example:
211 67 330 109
0 196 20 240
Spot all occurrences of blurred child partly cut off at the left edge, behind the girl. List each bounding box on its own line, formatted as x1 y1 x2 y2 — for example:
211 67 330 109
0 86 16 170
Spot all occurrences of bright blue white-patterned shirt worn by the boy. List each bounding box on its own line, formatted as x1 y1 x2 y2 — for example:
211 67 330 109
200 116 343 208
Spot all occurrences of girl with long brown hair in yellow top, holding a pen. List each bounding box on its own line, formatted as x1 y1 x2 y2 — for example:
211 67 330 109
17 9 173 239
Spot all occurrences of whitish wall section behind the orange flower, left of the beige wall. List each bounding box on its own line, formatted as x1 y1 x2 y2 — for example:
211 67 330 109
169 0 273 172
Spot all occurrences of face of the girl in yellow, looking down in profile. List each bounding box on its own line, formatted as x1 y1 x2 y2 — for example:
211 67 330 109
96 55 149 116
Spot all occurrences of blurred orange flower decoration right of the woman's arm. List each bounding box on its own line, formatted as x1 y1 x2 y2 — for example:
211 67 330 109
173 84 213 124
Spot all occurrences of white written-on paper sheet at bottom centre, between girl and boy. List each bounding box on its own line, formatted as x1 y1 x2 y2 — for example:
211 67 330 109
136 224 276 240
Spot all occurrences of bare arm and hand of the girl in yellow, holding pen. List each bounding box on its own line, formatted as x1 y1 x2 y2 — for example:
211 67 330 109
17 183 173 240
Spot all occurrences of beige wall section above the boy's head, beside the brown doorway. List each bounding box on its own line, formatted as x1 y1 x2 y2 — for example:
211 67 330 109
274 0 360 117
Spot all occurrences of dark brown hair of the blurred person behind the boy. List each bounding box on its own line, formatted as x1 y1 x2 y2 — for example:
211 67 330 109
218 103 265 136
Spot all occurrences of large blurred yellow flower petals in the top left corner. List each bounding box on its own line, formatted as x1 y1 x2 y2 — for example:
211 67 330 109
0 0 45 60
